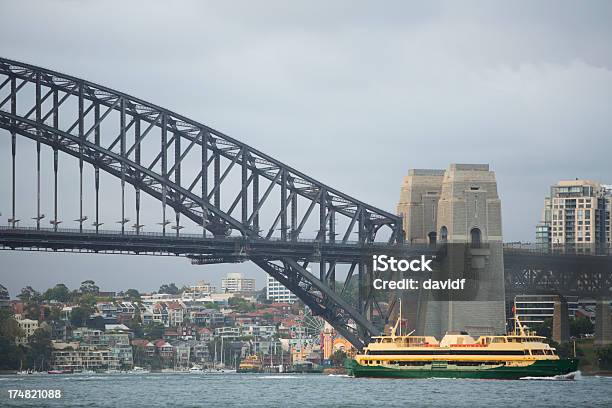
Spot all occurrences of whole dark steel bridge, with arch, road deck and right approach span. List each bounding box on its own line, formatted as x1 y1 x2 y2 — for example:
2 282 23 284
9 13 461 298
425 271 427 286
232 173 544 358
0 58 612 348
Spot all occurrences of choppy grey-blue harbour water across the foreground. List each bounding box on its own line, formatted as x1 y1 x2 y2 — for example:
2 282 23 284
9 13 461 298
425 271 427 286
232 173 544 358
0 373 612 408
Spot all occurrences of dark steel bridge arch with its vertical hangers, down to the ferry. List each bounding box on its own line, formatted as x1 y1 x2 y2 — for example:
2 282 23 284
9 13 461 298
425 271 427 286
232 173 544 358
0 58 403 347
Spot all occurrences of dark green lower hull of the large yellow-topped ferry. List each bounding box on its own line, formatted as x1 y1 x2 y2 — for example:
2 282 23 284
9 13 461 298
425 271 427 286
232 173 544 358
346 359 578 380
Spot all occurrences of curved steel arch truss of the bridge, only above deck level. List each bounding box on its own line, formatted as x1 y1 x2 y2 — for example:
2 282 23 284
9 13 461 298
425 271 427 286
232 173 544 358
0 58 402 242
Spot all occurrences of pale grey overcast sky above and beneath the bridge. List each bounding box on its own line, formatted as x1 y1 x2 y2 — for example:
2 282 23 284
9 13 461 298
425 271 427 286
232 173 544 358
0 0 612 296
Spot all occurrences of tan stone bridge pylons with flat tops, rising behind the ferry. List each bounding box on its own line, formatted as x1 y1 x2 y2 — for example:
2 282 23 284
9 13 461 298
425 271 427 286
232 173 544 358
398 164 506 337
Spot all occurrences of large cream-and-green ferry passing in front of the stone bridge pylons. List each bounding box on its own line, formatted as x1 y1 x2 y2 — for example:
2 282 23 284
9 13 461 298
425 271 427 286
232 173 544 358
346 310 578 379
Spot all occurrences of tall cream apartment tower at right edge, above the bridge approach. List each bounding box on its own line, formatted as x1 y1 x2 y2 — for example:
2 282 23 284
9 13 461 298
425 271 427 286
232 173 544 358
536 179 612 248
